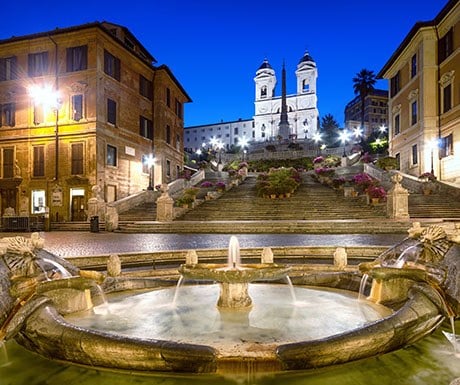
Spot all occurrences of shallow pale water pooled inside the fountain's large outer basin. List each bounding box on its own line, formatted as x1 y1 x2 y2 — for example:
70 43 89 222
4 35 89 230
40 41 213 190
66 283 391 356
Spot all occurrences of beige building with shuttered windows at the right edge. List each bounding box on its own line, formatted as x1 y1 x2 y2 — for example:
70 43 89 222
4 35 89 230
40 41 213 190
378 0 460 182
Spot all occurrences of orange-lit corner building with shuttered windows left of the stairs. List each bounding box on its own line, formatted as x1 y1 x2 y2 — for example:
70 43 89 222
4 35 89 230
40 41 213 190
0 22 190 222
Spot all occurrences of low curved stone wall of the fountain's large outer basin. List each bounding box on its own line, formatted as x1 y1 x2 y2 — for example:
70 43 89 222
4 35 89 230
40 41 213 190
11 273 444 373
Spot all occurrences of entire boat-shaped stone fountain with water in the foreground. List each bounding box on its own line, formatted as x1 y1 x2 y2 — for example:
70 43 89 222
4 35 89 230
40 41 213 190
0 226 460 373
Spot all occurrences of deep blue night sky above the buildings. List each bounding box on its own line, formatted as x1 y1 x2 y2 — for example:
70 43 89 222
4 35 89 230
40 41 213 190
0 0 447 126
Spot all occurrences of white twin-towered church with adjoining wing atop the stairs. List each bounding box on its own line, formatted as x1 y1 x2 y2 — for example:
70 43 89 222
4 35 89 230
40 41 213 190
184 53 319 151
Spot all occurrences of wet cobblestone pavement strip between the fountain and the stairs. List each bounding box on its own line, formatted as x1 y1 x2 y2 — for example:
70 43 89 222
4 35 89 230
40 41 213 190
0 231 404 257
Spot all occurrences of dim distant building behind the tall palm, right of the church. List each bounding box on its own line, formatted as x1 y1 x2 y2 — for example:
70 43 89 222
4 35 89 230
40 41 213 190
345 89 388 138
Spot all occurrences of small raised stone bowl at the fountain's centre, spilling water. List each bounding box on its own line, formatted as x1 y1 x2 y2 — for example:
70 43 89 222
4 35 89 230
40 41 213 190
179 263 291 283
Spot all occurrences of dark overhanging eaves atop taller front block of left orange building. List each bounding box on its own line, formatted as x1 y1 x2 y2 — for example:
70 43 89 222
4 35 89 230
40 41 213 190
0 21 157 65
